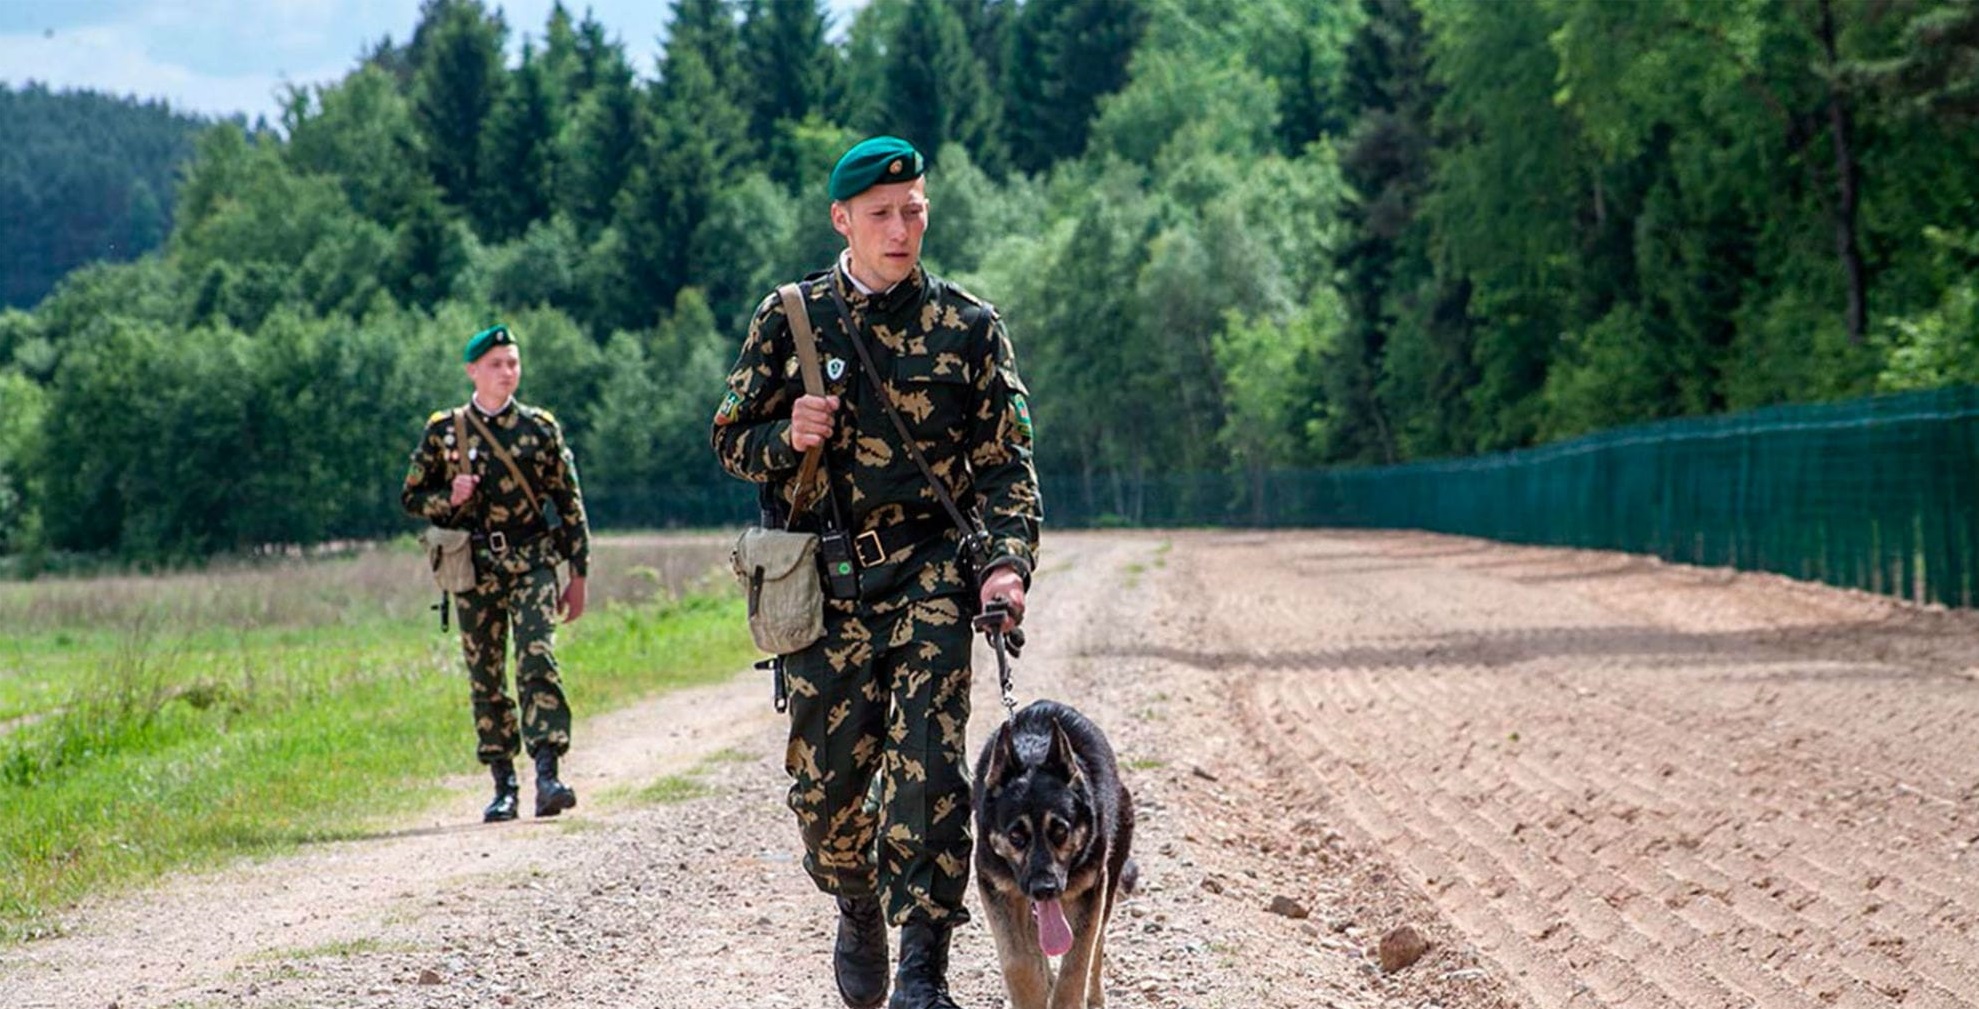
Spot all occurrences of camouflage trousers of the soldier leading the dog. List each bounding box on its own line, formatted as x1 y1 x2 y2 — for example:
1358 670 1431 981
784 597 972 924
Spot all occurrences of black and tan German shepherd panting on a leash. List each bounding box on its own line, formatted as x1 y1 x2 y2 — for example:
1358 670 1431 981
974 700 1136 1009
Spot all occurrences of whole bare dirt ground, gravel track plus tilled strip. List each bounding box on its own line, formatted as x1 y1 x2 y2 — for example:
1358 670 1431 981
0 532 1979 1009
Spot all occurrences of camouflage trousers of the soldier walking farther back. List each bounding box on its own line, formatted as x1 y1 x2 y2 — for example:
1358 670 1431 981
453 548 570 764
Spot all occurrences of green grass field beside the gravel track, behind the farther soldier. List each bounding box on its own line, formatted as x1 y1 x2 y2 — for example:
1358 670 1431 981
0 534 754 942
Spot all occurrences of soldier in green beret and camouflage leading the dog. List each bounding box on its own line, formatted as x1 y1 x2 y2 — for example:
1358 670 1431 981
712 137 1039 1009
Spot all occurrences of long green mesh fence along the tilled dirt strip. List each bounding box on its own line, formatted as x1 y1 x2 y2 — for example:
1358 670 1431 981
1043 388 1979 605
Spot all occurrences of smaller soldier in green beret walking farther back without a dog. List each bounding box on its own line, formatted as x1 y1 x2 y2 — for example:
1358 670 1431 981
400 326 590 823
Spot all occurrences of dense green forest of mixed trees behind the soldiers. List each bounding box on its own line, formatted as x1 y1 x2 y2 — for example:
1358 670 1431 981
0 0 1979 560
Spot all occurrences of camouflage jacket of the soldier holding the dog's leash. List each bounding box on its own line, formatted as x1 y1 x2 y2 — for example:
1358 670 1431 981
712 267 1041 605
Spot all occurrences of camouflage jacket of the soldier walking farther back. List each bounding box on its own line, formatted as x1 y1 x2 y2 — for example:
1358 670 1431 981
398 400 592 576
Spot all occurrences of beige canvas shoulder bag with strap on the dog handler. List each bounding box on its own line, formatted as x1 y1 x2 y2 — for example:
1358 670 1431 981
728 283 825 655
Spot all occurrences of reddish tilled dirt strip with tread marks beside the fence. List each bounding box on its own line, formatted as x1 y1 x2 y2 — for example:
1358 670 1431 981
1183 534 1979 1007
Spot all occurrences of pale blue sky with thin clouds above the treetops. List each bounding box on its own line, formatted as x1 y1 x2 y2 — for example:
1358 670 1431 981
0 0 865 121
